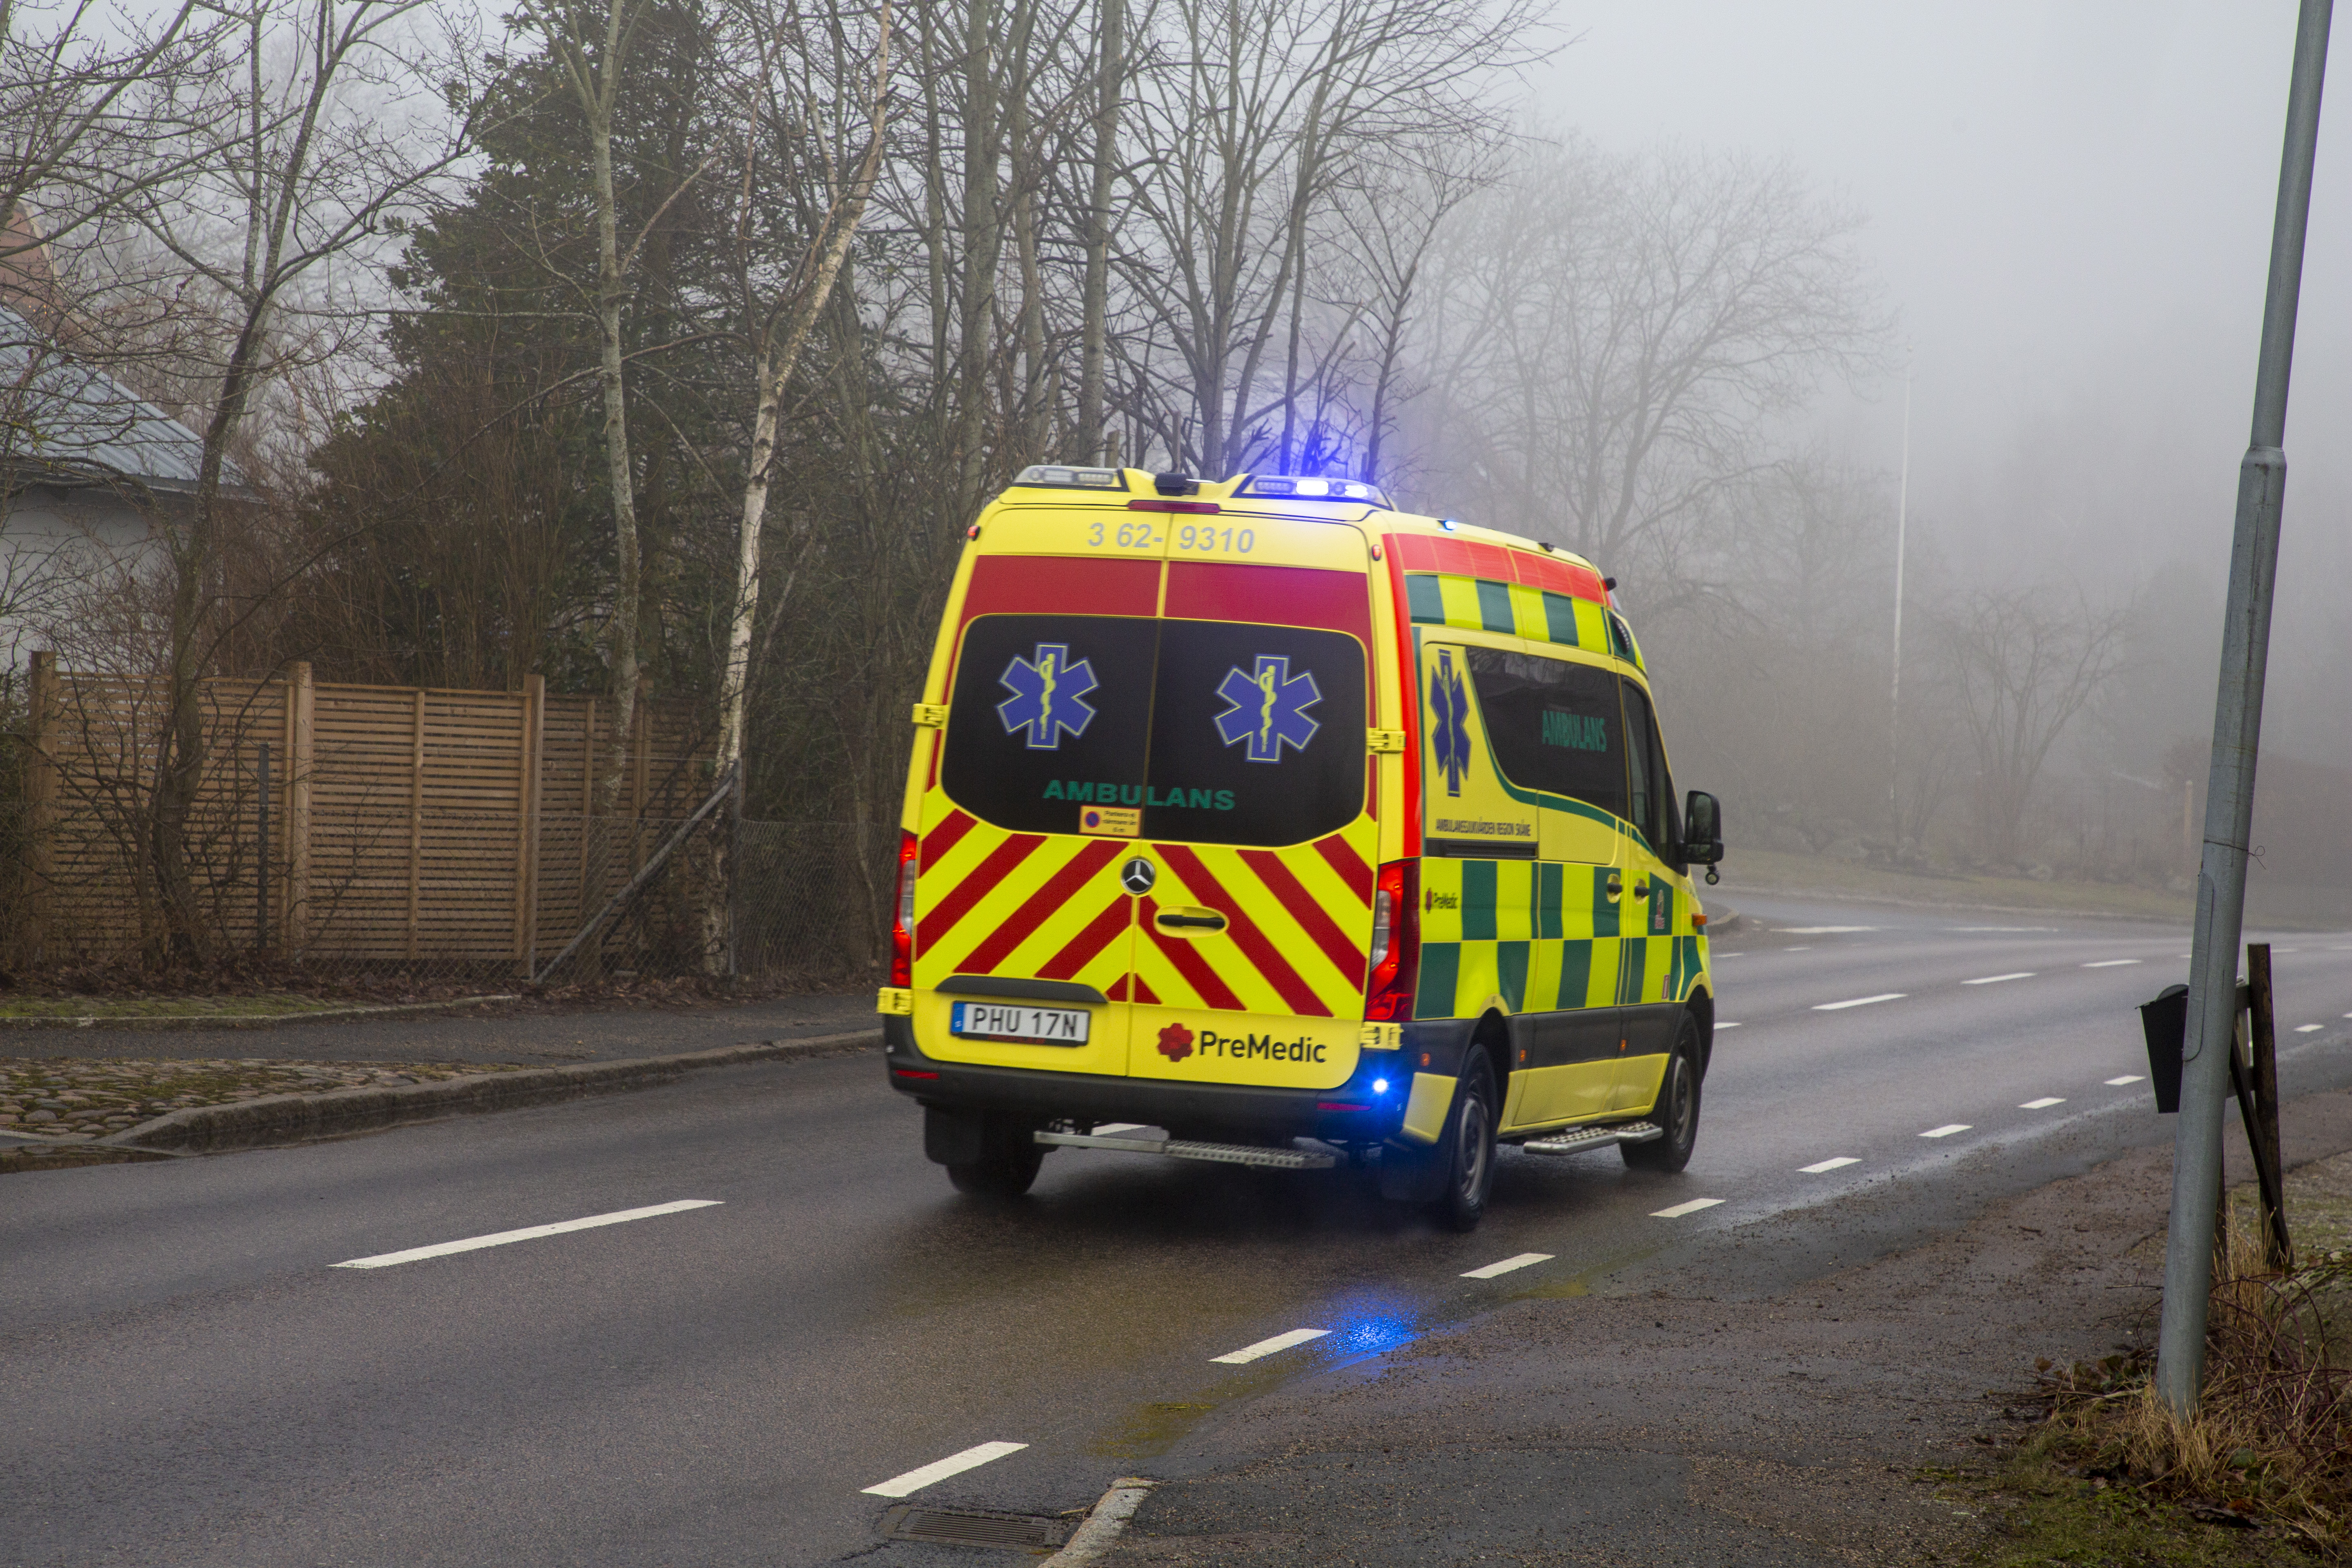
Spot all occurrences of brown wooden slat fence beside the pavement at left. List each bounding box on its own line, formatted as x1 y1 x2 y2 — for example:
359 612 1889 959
19 653 710 969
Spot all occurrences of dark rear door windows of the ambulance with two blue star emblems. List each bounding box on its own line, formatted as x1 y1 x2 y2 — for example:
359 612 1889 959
941 616 1364 844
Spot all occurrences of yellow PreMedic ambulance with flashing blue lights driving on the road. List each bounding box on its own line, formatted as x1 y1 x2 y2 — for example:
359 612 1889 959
880 466 1722 1229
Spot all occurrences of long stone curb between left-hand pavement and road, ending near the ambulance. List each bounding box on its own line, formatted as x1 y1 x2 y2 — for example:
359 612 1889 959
89 1030 882 1154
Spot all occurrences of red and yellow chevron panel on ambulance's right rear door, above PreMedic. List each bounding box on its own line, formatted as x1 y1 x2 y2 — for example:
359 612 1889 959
1134 818 1376 1018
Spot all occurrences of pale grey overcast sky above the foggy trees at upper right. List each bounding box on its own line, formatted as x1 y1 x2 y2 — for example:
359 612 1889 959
1531 0 2352 760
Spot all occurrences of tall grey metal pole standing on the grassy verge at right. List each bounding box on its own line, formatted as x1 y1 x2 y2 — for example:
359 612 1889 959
2157 0 2333 1415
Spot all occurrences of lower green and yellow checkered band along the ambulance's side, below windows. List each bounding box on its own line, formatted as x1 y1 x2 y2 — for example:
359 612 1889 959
1414 856 1703 1018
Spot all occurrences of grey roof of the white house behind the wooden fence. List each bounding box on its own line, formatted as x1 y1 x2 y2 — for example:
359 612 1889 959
0 294 228 491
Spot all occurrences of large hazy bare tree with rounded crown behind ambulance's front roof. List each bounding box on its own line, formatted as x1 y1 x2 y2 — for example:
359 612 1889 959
1423 141 1884 592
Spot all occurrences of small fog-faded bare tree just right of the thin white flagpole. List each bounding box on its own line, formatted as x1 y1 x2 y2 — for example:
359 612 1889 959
1936 588 2129 865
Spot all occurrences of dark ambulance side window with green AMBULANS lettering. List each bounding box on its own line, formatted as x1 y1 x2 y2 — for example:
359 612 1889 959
1468 649 1625 816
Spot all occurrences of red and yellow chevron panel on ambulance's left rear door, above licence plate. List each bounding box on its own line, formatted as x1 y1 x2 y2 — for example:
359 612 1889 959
915 797 1134 992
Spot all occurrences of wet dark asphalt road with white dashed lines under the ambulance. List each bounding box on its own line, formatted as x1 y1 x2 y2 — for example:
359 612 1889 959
0 898 2352 1566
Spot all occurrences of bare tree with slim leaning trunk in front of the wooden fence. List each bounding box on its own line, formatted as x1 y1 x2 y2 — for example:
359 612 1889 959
48 0 468 959
